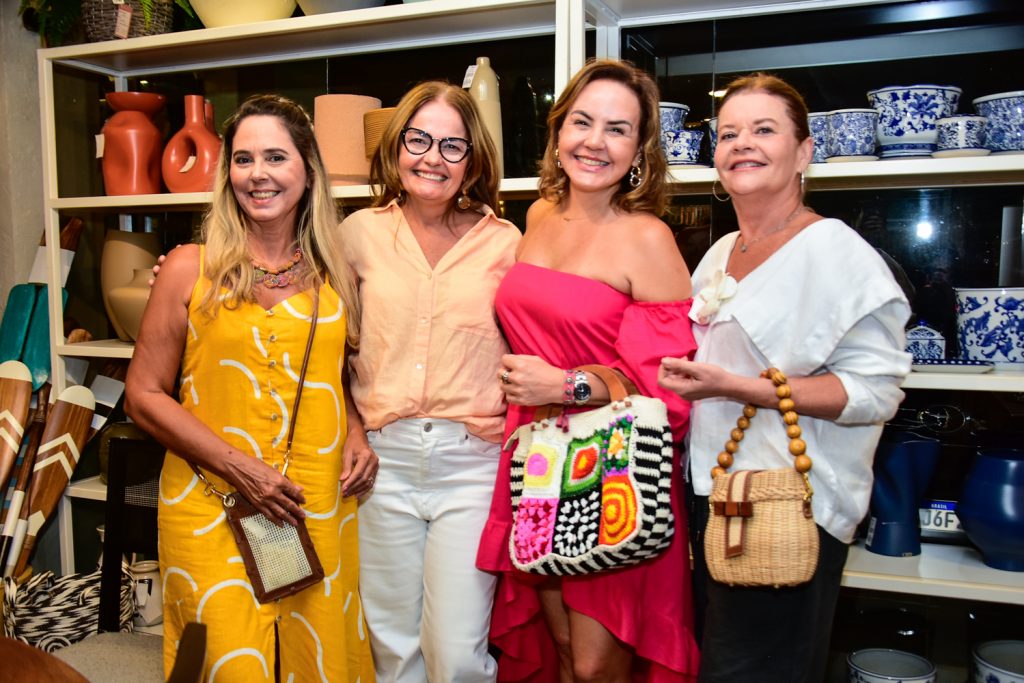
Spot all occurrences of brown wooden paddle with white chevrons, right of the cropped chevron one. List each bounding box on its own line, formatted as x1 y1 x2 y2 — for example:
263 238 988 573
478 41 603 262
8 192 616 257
4 386 96 577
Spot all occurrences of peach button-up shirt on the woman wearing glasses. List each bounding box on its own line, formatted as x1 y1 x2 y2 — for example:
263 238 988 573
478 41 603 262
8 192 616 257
341 202 520 442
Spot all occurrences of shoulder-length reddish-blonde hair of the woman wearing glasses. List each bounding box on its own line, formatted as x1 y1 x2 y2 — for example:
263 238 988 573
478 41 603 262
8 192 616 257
370 81 501 213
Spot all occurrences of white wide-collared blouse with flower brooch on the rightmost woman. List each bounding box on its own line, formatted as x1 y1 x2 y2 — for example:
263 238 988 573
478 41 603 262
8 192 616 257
689 218 911 543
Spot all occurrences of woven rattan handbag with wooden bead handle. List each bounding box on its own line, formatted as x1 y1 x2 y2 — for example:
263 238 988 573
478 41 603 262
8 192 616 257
705 368 818 587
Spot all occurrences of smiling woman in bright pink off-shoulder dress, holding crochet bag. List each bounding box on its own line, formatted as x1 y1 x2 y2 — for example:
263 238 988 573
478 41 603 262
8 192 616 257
477 60 698 683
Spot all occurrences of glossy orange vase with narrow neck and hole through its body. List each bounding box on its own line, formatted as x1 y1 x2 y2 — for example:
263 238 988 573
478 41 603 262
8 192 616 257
163 95 221 193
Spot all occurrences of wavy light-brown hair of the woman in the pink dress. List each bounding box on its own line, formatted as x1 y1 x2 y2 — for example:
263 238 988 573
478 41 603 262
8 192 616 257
540 59 669 216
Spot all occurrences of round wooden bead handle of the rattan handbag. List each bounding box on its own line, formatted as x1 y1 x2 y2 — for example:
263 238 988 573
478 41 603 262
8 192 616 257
711 368 814 517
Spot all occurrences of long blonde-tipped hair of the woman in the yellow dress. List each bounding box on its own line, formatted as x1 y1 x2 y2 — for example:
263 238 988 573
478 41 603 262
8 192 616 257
200 95 359 346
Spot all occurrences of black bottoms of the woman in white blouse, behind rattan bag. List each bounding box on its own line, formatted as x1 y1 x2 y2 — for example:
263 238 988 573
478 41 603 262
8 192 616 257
688 483 849 683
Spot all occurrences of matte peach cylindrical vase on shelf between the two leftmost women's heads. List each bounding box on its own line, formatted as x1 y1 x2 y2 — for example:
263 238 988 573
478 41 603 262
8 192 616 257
313 95 381 185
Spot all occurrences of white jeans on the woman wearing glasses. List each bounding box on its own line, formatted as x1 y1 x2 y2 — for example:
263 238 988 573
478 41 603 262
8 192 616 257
359 418 501 683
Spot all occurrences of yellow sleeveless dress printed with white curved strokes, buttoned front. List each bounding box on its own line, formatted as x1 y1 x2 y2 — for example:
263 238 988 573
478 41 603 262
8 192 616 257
160 264 374 683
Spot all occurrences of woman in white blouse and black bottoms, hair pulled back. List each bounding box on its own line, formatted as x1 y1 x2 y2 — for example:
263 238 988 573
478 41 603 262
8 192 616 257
659 74 910 683
